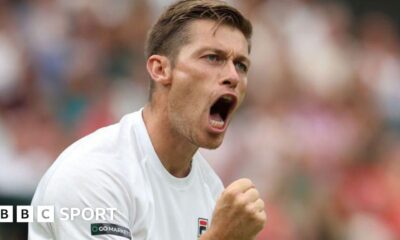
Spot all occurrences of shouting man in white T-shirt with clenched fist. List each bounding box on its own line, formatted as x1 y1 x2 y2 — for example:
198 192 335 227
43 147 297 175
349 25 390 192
29 0 266 240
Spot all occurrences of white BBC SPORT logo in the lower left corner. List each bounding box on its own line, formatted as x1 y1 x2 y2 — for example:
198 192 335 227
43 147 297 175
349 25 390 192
0 205 117 223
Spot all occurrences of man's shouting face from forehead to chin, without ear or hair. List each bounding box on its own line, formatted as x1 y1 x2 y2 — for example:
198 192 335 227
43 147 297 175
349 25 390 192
168 20 250 149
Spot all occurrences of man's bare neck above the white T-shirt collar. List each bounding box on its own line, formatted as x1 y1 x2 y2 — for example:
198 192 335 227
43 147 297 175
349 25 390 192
143 103 198 177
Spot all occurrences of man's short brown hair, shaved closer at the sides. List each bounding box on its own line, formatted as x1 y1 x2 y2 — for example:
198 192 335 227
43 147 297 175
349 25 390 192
145 0 252 98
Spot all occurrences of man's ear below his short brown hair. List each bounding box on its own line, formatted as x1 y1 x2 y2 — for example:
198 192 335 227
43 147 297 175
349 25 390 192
146 55 172 86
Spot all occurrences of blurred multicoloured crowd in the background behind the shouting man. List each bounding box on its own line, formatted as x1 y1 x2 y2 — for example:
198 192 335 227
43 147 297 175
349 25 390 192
0 0 400 240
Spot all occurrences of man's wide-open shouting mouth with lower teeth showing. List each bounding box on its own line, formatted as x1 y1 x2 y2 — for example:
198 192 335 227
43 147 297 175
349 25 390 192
209 94 236 129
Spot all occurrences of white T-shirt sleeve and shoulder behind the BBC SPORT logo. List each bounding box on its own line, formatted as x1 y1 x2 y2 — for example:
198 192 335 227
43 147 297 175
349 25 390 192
29 110 151 239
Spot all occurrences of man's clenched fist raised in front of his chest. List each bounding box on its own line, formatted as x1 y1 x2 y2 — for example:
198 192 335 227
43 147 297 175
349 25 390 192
200 179 267 240
